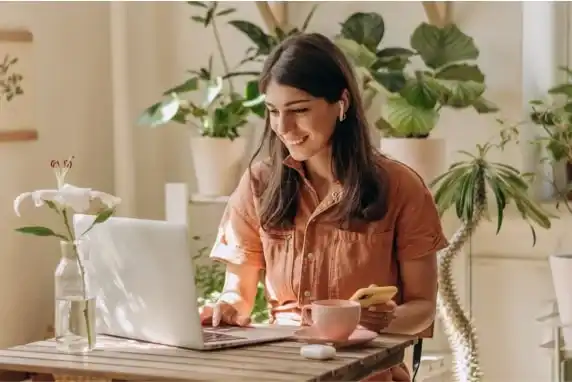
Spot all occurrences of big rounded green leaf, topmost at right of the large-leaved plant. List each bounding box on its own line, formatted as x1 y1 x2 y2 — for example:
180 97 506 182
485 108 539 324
411 23 479 69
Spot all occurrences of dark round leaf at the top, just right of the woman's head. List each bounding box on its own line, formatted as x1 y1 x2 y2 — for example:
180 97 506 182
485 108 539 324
341 12 385 52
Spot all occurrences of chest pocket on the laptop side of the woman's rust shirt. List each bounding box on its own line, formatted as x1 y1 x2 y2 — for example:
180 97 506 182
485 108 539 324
260 229 295 302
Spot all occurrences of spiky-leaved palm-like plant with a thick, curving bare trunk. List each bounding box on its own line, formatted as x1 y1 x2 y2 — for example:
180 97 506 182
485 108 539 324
430 126 554 382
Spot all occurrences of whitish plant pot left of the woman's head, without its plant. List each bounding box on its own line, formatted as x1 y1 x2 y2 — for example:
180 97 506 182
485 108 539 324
191 137 248 196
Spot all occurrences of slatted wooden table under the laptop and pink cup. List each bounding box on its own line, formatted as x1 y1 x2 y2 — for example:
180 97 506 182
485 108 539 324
0 335 416 382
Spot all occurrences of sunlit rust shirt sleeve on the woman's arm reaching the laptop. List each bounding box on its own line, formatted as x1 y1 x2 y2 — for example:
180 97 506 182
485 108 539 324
210 171 264 268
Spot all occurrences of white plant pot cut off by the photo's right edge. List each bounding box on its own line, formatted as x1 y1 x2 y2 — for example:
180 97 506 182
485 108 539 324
548 253 572 349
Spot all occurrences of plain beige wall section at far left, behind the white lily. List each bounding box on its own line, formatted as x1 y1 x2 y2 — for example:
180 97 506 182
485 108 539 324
0 2 113 346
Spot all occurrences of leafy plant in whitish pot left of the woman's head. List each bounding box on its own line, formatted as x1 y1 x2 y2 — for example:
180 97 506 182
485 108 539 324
139 1 264 196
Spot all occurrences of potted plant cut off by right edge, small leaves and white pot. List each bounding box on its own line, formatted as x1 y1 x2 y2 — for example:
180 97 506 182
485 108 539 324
526 67 572 347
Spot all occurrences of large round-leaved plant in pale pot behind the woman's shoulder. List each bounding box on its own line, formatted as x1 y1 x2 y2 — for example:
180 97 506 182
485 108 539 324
337 13 498 182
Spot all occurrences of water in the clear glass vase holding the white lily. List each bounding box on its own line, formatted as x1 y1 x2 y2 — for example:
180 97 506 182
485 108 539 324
55 296 96 353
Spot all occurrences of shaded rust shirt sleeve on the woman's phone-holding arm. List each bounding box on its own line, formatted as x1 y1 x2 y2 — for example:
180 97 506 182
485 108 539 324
396 172 449 261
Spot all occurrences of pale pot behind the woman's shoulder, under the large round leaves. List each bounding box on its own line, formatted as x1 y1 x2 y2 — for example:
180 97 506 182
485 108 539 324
381 137 447 184
